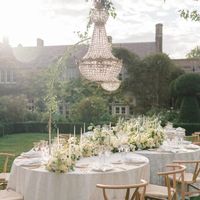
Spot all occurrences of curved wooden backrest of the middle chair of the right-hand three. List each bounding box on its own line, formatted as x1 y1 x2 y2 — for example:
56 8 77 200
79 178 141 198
158 164 186 200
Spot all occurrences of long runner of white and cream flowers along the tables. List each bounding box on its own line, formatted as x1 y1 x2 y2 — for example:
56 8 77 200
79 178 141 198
46 117 165 173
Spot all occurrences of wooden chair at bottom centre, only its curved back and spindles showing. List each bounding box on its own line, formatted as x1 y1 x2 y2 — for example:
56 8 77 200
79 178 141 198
96 180 148 200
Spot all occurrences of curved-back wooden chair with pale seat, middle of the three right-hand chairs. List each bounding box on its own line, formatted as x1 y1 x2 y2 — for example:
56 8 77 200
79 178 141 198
145 164 186 200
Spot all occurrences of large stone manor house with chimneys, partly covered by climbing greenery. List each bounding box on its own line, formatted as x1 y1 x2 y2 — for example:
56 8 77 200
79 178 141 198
0 24 200 115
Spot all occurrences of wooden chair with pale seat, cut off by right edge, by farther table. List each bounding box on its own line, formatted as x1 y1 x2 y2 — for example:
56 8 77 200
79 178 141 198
173 160 200 196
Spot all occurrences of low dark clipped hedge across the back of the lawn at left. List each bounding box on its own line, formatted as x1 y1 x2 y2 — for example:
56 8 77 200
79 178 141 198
0 122 92 136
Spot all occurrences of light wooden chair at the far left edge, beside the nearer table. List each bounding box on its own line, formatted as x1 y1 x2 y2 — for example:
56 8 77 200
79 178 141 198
0 153 15 189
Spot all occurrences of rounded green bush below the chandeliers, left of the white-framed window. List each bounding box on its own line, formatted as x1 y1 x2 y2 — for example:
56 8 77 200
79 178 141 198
71 96 110 123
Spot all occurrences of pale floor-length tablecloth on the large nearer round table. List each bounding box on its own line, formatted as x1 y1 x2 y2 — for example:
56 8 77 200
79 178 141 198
8 153 150 200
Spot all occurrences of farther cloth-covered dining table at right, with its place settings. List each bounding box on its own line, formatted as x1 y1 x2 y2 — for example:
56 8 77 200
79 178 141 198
136 144 200 185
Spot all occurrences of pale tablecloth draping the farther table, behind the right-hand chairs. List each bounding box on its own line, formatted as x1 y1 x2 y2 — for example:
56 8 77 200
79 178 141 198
136 145 200 184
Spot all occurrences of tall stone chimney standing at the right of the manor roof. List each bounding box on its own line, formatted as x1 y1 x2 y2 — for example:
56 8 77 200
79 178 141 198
155 24 163 53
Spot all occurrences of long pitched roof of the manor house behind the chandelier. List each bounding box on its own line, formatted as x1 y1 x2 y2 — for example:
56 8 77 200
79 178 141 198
10 42 156 68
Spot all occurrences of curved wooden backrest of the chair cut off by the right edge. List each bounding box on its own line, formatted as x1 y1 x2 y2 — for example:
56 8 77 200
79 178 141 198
173 160 200 183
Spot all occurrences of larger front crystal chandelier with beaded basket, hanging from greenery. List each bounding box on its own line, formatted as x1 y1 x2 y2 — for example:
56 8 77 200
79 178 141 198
79 0 122 83
